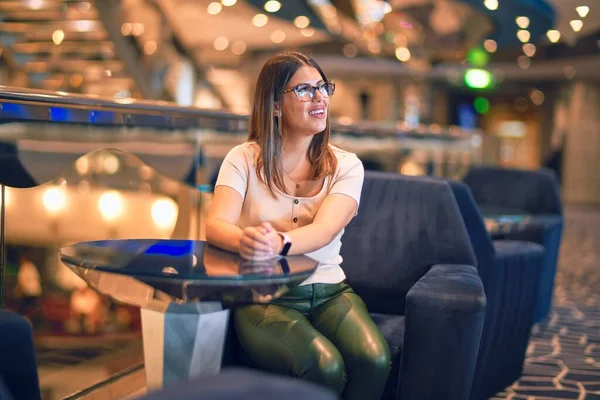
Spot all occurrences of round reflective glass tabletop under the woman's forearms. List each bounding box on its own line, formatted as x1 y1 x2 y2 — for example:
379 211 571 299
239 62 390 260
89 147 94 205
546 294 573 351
60 239 318 309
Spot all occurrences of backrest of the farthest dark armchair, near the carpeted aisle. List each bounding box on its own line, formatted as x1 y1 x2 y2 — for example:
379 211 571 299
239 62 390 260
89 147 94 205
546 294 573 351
463 166 562 215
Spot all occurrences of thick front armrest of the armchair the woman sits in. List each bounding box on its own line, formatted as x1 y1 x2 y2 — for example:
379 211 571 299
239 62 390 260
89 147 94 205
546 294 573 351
400 264 486 400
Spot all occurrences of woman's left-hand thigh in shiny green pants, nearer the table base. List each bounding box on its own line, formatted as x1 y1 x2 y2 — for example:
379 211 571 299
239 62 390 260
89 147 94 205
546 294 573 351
234 304 345 394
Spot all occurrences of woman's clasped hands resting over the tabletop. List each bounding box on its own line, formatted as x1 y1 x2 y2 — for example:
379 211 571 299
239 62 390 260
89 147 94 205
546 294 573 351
239 222 283 260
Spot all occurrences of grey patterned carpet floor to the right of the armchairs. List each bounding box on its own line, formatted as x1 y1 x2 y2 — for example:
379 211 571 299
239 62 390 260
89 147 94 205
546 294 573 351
492 207 600 400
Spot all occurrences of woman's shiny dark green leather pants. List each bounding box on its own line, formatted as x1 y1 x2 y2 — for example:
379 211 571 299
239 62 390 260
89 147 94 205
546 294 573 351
234 283 391 400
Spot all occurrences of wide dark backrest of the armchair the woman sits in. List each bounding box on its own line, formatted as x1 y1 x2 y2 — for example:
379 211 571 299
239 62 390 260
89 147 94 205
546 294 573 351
341 171 475 315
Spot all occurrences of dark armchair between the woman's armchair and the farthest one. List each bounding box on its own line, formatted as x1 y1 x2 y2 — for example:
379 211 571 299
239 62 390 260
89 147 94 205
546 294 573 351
448 181 544 400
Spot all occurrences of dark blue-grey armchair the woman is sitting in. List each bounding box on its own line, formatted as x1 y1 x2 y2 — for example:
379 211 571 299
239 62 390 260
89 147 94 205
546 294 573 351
342 171 486 400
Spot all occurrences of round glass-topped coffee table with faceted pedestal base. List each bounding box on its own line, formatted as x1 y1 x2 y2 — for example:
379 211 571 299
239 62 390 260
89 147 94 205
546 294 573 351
60 239 318 389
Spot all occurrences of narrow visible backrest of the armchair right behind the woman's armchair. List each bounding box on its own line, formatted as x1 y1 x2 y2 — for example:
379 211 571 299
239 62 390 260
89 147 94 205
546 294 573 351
447 180 496 289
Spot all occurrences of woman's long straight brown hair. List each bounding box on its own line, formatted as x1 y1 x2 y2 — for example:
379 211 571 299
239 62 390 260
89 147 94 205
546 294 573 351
248 52 337 197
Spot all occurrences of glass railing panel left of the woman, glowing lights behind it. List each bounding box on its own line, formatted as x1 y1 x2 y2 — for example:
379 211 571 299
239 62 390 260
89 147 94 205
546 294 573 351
2 127 207 399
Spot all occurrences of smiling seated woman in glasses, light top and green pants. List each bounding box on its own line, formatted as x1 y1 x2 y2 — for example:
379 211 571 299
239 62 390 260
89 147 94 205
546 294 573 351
206 53 390 400
